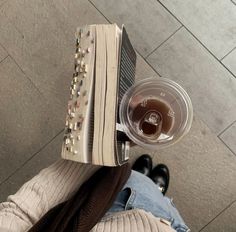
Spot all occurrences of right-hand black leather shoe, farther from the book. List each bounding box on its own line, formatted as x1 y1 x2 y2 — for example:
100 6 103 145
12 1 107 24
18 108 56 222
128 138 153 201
149 164 170 195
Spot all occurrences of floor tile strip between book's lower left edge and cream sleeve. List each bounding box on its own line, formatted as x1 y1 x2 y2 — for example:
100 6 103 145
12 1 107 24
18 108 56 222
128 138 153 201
0 133 63 202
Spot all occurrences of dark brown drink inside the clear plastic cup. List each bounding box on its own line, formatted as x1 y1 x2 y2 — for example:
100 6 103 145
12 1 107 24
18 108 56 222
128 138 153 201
131 99 174 137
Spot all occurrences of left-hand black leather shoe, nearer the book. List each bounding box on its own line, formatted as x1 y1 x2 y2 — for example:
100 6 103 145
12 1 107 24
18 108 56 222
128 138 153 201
132 154 152 176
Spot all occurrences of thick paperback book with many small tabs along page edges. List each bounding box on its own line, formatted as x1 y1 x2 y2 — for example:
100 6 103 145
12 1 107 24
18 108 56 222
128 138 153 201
61 24 136 166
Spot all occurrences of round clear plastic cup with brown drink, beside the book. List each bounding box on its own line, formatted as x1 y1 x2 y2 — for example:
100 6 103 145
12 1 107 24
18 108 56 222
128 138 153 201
119 77 193 150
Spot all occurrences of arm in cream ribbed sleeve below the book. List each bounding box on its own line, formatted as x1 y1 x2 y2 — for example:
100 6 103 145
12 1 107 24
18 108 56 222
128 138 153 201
0 160 99 232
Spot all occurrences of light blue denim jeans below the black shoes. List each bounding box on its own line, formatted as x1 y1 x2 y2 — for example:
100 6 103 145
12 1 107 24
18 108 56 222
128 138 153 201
108 171 190 232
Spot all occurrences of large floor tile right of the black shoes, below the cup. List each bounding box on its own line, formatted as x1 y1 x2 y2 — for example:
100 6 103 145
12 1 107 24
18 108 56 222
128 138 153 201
154 117 236 231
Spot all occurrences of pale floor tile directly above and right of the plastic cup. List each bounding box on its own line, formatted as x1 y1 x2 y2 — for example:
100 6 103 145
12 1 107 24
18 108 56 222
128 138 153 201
147 28 236 134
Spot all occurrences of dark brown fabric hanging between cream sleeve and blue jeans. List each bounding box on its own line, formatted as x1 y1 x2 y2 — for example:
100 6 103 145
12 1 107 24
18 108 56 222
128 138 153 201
29 163 131 232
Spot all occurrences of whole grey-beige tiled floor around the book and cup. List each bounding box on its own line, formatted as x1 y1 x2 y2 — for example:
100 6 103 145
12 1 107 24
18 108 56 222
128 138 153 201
0 0 236 232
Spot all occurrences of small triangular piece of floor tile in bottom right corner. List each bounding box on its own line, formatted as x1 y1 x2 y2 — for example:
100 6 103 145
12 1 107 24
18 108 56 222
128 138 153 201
201 203 236 232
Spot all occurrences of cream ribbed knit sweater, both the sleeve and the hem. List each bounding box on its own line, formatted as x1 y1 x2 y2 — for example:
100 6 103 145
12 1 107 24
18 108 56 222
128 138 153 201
0 160 174 232
